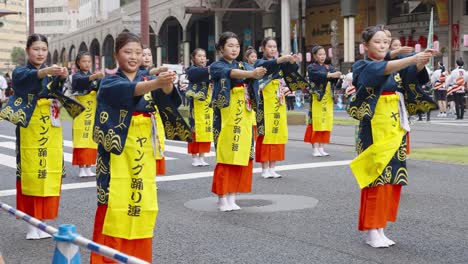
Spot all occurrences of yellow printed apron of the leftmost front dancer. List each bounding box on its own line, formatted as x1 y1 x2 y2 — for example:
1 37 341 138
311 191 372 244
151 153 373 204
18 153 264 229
20 99 63 197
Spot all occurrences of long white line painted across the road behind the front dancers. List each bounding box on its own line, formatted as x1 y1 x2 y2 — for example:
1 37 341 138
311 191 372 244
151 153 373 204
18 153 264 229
0 160 351 197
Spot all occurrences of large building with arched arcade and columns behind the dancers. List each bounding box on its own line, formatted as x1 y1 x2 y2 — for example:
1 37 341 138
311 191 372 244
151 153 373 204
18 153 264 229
44 0 468 71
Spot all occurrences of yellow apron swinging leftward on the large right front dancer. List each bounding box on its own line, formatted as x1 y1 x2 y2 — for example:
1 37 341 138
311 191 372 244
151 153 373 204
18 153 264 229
350 94 406 188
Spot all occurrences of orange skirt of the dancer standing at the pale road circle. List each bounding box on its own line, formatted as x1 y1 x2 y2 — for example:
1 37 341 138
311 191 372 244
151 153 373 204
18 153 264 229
211 160 253 195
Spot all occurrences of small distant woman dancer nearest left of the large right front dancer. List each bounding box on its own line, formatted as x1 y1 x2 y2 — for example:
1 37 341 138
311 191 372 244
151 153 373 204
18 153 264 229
304 46 341 157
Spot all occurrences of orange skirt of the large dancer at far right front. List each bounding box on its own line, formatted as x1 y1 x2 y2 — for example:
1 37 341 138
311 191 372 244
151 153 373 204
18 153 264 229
358 184 401 231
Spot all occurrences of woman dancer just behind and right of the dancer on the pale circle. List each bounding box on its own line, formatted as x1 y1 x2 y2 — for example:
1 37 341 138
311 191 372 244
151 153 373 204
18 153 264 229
255 37 298 178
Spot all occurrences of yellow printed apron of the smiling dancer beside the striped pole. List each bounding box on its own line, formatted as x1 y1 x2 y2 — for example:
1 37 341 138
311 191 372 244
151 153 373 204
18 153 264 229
103 115 158 239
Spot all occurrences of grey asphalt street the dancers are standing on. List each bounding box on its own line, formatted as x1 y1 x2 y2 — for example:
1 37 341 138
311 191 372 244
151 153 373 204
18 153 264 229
0 111 468 264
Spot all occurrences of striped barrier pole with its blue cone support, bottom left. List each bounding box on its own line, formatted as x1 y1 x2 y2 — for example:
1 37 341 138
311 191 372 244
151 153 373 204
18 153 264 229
0 202 149 264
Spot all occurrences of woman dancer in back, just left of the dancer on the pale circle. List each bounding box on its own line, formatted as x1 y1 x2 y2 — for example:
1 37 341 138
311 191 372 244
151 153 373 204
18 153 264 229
185 48 213 167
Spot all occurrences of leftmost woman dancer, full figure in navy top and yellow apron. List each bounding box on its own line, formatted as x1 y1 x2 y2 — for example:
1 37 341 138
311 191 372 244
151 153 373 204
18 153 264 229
0 34 84 239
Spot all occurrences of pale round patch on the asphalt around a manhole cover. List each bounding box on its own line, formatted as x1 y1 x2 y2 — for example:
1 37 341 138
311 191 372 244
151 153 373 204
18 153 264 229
184 194 318 213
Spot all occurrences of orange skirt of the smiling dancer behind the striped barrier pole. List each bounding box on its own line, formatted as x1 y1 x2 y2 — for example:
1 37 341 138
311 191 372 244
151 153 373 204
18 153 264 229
91 205 153 264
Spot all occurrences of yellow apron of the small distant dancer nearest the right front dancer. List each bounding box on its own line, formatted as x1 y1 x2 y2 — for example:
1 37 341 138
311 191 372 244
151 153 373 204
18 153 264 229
312 82 333 131
